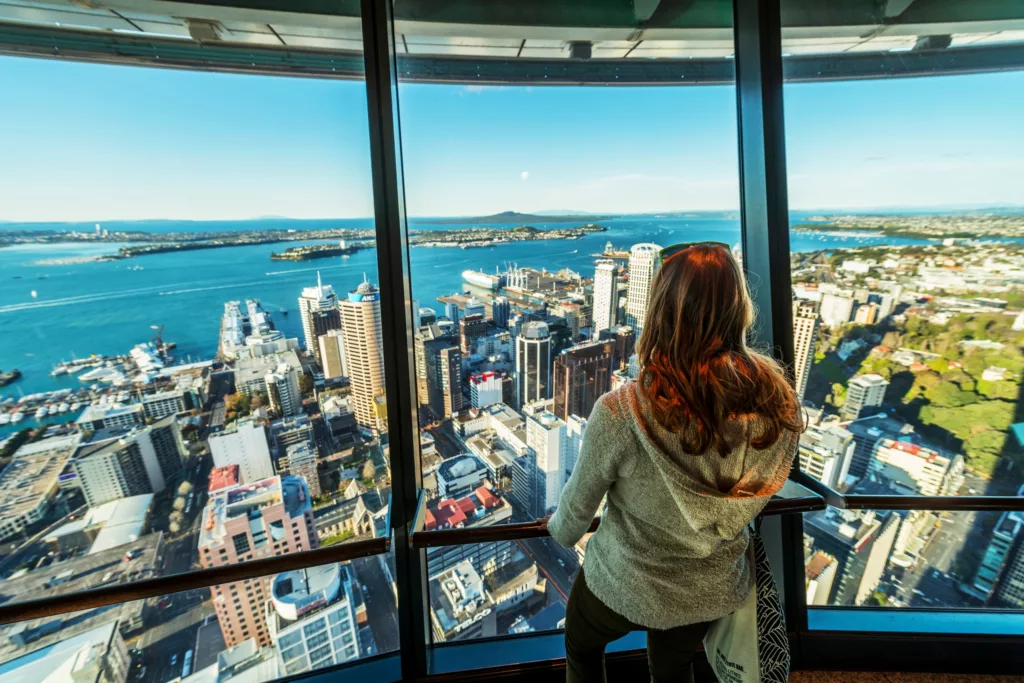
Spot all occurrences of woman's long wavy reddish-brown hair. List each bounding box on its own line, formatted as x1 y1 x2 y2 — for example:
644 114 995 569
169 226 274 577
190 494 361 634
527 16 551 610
637 245 803 457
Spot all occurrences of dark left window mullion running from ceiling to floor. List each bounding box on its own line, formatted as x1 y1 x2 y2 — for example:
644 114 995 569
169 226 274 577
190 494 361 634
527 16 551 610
361 0 430 680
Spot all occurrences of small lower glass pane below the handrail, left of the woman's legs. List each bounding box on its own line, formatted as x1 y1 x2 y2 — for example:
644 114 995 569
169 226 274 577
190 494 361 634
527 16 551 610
427 539 586 643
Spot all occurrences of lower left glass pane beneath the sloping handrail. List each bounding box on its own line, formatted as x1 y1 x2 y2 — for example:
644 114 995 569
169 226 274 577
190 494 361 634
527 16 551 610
0 555 398 683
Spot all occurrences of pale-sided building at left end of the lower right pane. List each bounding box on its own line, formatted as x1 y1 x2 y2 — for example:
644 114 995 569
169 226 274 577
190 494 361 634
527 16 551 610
804 510 901 605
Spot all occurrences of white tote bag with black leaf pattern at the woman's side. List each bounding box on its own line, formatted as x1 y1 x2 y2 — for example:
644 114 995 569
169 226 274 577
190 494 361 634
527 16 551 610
705 529 790 683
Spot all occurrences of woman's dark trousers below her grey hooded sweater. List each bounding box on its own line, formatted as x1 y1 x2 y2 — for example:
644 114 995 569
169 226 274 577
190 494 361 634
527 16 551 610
565 569 711 683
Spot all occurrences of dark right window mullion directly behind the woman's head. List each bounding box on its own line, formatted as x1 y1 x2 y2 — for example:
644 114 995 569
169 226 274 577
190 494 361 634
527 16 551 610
733 0 807 643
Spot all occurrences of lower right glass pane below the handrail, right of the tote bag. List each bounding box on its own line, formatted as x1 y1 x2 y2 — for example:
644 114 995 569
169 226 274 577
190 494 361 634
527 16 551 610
804 510 1024 609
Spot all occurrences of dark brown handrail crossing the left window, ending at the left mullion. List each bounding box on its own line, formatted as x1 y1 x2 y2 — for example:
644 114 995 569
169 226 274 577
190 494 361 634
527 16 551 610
0 535 391 626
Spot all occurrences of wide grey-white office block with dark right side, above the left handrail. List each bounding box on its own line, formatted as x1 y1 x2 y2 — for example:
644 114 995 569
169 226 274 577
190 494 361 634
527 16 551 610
72 416 188 507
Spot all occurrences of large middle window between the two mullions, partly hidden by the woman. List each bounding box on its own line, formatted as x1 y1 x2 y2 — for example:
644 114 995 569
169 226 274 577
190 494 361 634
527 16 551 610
395 2 740 640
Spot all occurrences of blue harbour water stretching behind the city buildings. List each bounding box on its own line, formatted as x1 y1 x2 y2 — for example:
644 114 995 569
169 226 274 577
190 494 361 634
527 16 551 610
0 214 966 433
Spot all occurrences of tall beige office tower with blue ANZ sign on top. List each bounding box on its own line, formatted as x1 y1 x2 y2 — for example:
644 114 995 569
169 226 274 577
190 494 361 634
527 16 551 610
339 282 386 433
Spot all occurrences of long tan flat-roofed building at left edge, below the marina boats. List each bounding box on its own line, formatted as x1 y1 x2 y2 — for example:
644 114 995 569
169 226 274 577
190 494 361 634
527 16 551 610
0 434 79 541
